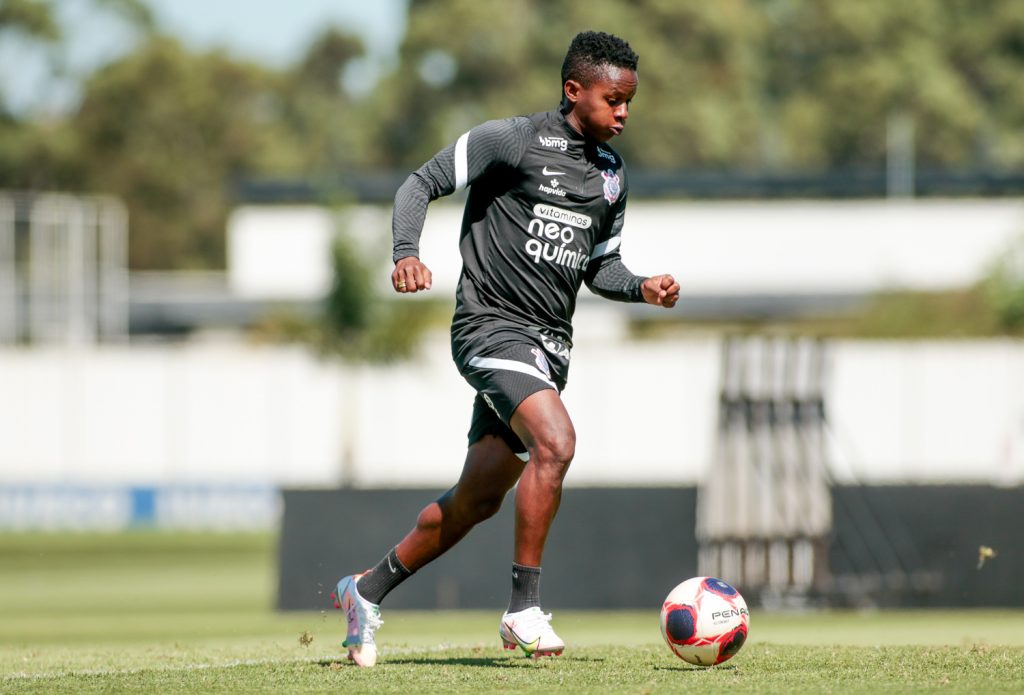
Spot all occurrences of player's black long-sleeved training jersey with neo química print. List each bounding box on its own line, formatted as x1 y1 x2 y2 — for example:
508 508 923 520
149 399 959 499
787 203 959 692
392 111 644 354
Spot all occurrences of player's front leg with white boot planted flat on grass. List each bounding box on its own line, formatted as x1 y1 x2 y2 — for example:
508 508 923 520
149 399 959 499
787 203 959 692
499 389 575 656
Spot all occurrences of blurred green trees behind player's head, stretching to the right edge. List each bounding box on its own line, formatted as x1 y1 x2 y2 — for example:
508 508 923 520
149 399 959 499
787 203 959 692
375 0 1024 171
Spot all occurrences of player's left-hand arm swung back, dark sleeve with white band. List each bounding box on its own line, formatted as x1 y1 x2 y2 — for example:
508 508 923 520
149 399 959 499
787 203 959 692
391 118 534 292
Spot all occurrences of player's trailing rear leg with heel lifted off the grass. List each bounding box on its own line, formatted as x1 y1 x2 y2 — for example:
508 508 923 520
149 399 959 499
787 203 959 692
335 435 523 666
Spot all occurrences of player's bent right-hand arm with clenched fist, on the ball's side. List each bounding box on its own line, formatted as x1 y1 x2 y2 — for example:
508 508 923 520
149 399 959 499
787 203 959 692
584 197 679 308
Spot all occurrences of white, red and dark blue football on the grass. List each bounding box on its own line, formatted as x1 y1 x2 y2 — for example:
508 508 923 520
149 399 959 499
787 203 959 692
662 576 751 666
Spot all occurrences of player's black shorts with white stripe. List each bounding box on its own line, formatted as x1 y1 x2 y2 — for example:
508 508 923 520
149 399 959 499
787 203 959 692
456 329 569 460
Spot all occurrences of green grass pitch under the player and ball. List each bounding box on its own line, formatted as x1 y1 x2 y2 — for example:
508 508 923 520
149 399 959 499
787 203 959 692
0 533 1024 693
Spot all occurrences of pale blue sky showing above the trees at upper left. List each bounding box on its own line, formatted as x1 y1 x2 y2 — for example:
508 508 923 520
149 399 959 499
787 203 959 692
0 0 407 113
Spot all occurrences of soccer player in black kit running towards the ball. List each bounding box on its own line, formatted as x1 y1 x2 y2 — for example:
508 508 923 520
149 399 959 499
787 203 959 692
333 32 679 666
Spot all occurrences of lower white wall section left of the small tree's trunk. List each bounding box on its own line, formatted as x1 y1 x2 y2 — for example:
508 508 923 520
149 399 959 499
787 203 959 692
0 345 343 484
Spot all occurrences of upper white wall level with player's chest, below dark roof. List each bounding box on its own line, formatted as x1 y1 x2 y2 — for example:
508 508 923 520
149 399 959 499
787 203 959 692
228 199 1024 299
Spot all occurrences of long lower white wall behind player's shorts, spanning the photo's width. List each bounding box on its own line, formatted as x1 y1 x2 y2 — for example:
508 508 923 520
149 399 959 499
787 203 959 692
0 333 1024 486
